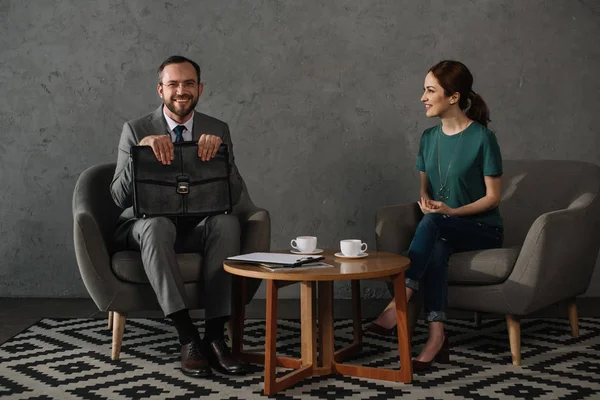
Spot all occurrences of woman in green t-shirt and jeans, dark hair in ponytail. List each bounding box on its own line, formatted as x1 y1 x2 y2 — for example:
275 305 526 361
367 60 503 372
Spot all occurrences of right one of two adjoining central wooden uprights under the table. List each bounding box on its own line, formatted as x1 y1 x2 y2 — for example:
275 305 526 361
315 281 335 375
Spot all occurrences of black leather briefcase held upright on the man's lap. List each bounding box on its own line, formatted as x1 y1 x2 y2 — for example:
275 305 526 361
130 142 232 218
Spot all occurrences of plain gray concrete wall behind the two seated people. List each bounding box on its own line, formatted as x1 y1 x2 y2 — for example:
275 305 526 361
0 0 600 297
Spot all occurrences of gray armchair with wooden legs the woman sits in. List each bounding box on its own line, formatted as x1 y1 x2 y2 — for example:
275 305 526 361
376 160 600 365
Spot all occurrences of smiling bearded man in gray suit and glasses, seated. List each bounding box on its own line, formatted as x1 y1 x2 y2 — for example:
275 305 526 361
111 56 247 377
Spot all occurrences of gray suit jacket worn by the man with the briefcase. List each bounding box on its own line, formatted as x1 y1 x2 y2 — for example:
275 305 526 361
110 105 242 237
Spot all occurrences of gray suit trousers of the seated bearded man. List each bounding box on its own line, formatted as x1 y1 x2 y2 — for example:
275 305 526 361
127 214 241 319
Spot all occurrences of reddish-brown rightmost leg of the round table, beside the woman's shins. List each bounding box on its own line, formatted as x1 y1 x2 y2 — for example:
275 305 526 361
392 272 412 383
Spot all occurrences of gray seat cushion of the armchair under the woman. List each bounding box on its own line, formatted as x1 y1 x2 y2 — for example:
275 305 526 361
448 246 521 285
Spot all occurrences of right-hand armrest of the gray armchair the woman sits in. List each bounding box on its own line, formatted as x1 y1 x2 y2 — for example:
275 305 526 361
504 193 600 315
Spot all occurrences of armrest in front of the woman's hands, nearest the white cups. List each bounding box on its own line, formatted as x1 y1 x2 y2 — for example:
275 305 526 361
375 203 423 254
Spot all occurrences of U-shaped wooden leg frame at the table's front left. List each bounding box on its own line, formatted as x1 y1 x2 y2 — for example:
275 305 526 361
265 280 316 396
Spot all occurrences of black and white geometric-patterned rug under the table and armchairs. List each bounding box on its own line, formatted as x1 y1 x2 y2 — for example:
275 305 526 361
0 318 600 400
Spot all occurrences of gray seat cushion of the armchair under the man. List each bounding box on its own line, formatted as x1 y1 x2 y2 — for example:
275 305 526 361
111 251 202 284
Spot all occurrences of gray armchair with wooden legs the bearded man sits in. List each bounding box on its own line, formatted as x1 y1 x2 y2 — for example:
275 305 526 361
73 163 271 360
